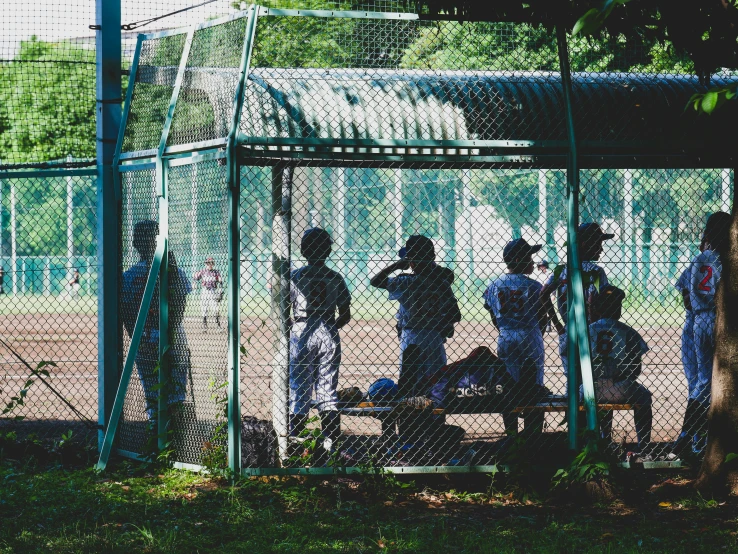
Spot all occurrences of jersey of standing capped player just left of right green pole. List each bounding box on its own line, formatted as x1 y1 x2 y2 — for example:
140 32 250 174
484 274 543 329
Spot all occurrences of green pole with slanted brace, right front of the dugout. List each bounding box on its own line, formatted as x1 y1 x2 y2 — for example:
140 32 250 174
556 25 597 450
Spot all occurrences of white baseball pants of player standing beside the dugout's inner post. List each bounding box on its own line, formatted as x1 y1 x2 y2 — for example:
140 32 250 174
290 320 341 415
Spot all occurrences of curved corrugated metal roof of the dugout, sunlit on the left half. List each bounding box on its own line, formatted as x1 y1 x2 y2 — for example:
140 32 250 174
129 65 738 168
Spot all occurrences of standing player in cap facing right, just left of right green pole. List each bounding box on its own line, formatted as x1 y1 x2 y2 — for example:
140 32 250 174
484 239 546 435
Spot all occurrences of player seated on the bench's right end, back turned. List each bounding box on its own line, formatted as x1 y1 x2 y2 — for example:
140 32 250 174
589 285 653 455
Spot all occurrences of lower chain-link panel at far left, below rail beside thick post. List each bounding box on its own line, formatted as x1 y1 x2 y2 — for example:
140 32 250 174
0 171 98 436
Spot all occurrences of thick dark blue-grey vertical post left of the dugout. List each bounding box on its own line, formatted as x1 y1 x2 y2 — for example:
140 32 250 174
95 0 122 448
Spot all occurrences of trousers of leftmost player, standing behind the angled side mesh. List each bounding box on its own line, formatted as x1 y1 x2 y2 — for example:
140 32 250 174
136 324 190 421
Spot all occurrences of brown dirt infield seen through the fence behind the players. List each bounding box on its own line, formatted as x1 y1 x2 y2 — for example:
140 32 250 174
0 314 686 441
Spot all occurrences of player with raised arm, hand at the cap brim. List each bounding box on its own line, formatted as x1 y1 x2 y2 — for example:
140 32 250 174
370 235 461 397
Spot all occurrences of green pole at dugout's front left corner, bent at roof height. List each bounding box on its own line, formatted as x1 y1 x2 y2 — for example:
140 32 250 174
226 6 258 475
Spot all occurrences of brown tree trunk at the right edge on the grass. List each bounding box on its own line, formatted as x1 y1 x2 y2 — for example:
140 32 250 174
696 210 738 495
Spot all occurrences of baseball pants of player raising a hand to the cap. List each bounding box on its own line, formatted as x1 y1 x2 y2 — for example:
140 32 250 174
398 329 447 396
